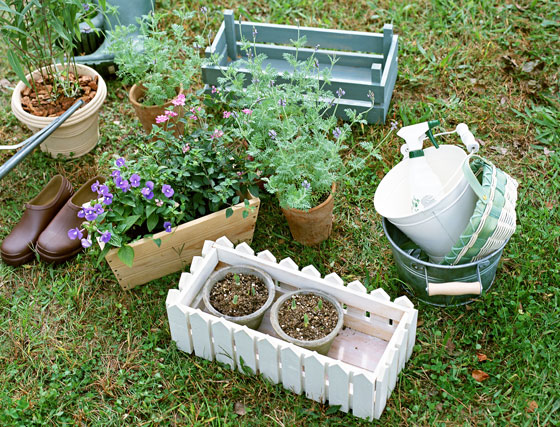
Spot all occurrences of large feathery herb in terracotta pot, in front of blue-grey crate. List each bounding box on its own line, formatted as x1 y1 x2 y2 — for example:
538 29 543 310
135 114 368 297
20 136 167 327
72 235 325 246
220 41 367 245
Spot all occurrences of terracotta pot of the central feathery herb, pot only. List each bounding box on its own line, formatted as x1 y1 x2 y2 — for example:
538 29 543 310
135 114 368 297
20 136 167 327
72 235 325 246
282 183 336 246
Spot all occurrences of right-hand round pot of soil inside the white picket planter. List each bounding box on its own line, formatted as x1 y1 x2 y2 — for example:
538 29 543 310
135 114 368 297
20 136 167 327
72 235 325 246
270 290 344 354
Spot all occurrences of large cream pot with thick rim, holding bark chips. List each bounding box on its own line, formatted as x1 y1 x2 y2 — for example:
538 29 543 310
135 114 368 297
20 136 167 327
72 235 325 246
11 64 107 158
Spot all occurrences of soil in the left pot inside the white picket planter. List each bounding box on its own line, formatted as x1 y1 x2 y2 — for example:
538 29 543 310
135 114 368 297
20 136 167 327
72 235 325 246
210 273 268 317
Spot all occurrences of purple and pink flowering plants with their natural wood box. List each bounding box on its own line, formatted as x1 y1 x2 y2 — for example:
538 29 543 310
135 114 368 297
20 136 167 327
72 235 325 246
75 96 260 289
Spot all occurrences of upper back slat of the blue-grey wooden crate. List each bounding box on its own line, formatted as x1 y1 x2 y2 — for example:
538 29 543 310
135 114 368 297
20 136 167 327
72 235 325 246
235 21 383 53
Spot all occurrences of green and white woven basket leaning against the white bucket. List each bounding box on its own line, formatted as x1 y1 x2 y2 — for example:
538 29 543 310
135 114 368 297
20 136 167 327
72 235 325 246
441 155 518 265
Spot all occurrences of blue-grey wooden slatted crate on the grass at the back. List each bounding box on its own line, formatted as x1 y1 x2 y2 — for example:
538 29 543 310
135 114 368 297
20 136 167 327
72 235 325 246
202 10 398 123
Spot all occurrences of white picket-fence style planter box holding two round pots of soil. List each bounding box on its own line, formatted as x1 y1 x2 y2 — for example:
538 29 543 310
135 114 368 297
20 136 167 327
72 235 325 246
166 237 418 419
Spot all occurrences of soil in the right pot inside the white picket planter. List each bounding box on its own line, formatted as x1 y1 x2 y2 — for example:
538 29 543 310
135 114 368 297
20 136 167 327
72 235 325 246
278 294 338 341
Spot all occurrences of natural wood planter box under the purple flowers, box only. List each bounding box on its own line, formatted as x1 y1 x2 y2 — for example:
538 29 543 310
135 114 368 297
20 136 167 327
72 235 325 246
100 197 260 290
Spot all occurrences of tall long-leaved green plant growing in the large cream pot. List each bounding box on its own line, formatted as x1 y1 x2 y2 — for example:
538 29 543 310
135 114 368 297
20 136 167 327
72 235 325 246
0 0 102 101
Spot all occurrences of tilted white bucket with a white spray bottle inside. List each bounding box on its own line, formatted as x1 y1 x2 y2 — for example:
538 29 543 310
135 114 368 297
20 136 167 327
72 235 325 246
374 120 479 264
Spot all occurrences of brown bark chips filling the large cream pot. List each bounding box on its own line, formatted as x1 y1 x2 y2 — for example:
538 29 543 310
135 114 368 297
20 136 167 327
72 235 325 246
21 73 98 117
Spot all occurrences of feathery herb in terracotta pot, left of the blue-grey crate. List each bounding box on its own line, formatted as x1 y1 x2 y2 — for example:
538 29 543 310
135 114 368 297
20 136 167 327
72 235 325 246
109 10 204 133
